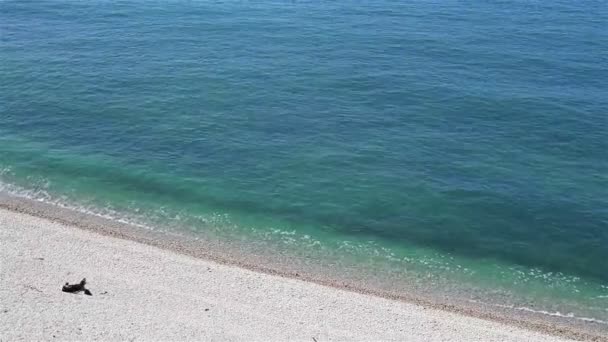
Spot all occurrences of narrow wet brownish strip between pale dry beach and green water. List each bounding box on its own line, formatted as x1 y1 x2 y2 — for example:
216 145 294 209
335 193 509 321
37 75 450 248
0 193 608 341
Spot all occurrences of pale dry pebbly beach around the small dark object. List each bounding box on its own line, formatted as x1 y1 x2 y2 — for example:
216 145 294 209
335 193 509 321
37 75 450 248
0 209 576 342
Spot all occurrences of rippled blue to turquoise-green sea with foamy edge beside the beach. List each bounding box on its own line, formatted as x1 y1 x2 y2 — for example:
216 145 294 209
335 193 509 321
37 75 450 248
0 0 608 320
